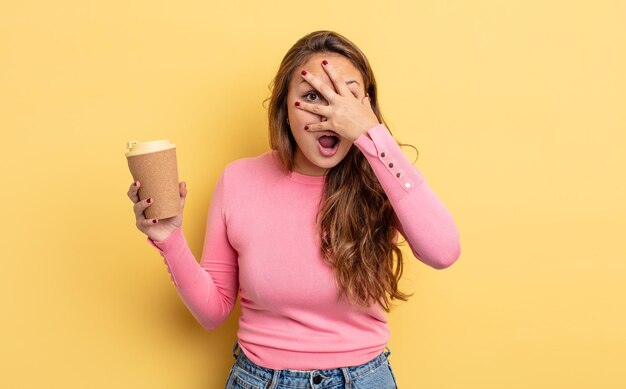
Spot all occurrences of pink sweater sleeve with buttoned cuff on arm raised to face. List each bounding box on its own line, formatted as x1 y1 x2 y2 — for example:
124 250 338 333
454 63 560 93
354 124 461 269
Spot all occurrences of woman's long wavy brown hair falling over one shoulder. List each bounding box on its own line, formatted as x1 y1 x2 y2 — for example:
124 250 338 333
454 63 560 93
265 30 412 312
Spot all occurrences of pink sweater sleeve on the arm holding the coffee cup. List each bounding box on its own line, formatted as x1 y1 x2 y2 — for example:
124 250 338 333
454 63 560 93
147 169 239 330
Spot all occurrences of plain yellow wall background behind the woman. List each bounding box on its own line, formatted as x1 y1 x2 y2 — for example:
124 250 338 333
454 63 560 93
0 0 626 389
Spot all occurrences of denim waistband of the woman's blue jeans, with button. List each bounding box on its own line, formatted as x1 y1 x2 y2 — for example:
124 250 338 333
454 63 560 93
232 341 391 388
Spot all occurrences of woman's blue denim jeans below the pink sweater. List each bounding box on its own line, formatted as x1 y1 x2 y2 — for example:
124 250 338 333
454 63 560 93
225 341 398 389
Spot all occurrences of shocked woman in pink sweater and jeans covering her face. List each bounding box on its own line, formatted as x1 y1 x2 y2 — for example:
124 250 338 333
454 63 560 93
128 31 460 388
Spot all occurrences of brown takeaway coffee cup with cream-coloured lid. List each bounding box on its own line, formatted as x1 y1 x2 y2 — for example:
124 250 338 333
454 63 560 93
126 139 182 219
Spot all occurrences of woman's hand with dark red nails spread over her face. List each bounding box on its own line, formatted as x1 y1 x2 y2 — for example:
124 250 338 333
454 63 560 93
296 61 380 142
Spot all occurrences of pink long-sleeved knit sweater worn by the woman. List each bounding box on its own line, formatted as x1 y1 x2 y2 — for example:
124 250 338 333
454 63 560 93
147 124 460 370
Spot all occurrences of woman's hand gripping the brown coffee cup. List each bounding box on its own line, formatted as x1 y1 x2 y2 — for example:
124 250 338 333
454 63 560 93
128 181 187 242
